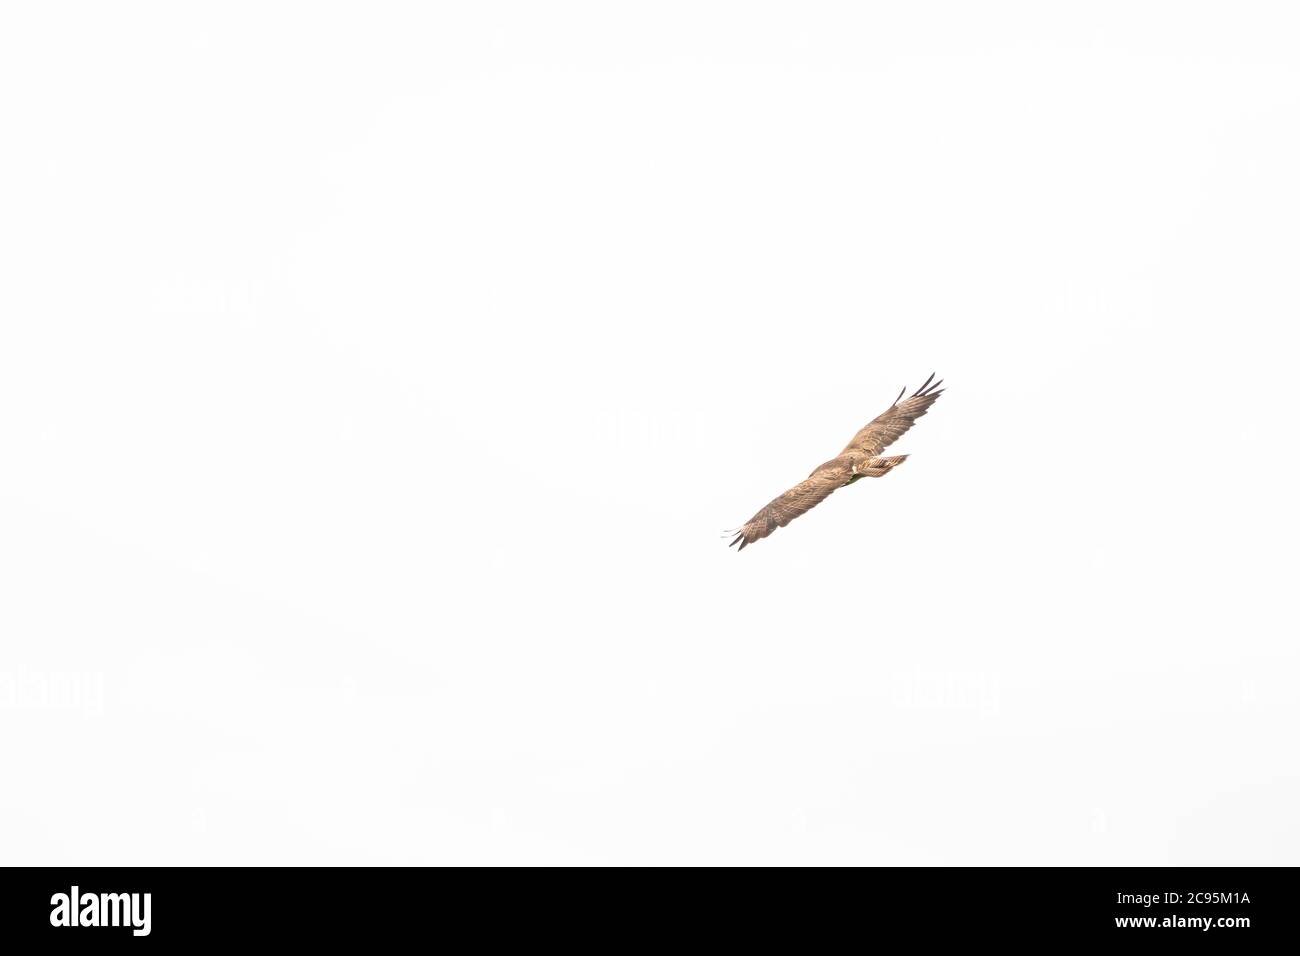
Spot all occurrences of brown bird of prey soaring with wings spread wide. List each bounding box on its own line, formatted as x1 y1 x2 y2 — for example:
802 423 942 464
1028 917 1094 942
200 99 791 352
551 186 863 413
728 375 944 551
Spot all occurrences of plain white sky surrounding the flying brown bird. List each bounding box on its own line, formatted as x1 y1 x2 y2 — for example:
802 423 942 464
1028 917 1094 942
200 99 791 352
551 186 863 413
0 3 1300 864
